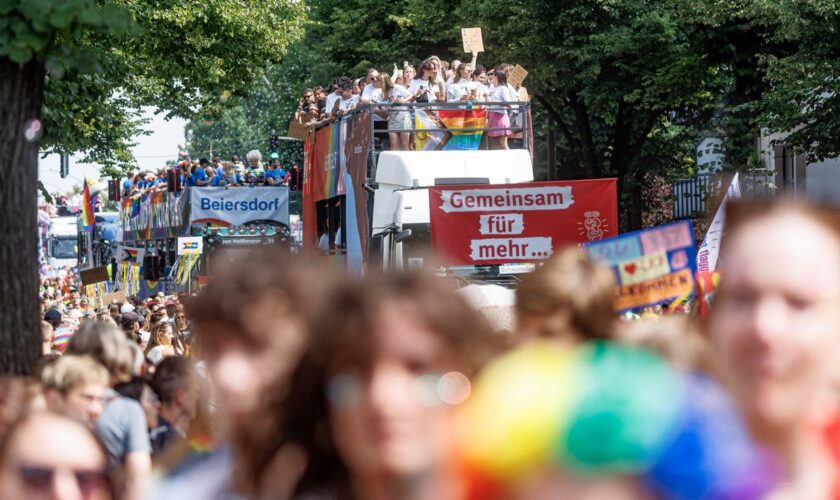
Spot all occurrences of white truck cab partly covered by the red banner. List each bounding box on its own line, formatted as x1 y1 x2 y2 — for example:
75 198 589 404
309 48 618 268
371 149 534 269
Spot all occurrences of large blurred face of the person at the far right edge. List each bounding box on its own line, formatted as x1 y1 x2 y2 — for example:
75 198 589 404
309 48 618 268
709 201 840 494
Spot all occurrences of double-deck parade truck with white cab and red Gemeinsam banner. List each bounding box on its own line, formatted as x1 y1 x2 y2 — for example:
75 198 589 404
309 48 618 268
303 102 618 283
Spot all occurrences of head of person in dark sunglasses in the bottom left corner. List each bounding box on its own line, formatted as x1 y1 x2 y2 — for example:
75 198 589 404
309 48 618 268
0 412 113 500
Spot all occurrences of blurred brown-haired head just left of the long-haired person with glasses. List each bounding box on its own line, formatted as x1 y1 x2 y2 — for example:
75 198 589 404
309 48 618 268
187 249 337 426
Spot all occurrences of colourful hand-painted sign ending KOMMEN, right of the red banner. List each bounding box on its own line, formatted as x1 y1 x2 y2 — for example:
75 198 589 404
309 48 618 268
587 221 696 311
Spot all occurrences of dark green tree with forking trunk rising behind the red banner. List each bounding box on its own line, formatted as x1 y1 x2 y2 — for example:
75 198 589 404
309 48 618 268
465 0 717 228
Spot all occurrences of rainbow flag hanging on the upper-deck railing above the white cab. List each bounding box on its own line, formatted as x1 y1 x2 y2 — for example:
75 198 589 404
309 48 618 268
414 108 487 151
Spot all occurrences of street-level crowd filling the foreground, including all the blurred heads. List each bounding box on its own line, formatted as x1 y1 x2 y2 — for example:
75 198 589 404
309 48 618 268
6 197 840 500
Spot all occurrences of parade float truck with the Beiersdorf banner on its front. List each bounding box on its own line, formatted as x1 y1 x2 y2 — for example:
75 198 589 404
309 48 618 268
116 186 290 296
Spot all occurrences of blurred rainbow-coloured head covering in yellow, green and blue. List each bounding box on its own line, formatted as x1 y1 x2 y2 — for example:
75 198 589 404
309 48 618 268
456 341 770 500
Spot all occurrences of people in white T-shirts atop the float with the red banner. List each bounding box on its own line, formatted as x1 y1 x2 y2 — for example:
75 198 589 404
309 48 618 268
297 53 523 151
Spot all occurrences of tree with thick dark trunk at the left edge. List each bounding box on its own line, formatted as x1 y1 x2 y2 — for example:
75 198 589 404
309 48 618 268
0 0 304 373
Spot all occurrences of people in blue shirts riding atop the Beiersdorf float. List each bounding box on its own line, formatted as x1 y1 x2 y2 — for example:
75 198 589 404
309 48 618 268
121 149 300 198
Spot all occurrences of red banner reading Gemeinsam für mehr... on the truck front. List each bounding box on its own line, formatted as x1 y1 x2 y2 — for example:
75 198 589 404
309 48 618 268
429 179 618 265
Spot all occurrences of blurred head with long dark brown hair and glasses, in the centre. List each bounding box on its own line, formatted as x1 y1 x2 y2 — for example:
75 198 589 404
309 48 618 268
243 273 500 498
